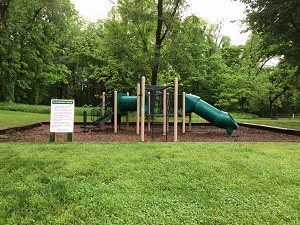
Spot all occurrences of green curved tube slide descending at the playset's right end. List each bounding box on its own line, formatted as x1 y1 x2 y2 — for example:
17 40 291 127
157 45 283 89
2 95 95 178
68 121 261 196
185 94 239 134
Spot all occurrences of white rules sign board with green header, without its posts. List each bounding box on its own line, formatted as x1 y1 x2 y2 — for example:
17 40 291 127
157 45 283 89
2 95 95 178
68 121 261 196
50 99 75 133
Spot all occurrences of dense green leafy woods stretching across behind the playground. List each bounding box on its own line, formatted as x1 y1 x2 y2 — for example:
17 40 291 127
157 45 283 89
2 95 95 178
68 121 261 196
0 0 300 117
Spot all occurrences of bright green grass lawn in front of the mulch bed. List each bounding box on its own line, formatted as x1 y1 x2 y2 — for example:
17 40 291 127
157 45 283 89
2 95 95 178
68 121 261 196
0 143 300 224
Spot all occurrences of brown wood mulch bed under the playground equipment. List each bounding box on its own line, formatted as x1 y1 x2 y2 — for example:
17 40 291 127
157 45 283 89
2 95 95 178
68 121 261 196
0 124 300 142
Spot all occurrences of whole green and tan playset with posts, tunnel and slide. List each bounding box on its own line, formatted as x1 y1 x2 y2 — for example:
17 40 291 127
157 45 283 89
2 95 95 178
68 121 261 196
83 77 238 141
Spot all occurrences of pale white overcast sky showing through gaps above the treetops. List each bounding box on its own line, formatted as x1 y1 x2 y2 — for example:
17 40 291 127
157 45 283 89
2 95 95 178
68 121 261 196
70 0 248 45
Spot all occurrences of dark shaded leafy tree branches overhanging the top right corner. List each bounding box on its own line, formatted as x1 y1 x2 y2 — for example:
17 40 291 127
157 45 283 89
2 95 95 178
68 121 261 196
235 0 300 73
